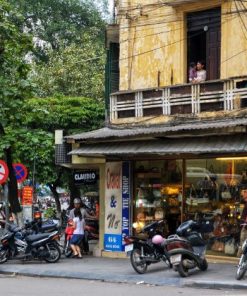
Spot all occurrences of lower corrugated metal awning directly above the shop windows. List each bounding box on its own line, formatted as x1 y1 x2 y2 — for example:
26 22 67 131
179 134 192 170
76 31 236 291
69 135 247 156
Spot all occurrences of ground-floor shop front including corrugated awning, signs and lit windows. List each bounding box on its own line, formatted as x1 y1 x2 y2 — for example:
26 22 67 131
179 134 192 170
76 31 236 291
67 125 247 257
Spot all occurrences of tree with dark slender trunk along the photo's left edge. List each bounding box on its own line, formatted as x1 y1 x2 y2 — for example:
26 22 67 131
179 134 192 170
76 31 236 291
0 0 32 213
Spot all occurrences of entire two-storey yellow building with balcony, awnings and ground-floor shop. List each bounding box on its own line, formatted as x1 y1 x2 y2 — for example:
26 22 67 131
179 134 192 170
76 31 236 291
60 0 247 256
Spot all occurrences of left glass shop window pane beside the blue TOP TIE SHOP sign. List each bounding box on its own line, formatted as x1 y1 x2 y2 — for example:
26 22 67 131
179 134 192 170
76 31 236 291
133 160 182 235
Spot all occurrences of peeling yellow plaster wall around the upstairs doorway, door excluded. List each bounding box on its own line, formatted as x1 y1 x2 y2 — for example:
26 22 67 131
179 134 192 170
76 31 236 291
118 0 247 90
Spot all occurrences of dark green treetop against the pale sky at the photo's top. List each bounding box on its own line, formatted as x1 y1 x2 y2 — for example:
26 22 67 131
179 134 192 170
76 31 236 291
10 0 106 61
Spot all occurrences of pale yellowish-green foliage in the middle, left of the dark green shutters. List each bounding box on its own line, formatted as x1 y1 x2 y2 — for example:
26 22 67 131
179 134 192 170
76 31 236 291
31 34 105 100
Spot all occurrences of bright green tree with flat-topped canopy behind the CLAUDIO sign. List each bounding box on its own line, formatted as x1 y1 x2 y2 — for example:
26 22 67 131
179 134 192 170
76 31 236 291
12 97 104 215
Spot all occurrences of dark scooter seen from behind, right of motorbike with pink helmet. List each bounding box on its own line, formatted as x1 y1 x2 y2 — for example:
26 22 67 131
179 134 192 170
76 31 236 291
166 220 212 277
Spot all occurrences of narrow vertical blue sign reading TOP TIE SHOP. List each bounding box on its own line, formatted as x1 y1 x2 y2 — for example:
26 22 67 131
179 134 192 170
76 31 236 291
122 162 130 250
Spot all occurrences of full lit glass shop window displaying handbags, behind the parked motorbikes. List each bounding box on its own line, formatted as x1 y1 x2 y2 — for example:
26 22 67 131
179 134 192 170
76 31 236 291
133 157 247 256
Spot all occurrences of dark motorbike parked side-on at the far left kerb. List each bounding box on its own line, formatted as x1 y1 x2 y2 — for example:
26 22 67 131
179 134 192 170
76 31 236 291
0 224 61 263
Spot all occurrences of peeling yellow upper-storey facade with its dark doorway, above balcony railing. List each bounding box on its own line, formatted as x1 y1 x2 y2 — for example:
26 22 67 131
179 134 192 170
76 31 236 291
114 0 247 90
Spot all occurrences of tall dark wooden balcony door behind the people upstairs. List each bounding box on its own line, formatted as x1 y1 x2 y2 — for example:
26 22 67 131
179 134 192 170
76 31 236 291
187 8 221 80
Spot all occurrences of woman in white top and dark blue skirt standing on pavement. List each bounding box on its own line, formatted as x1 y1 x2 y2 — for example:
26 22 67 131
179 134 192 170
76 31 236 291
70 209 85 258
